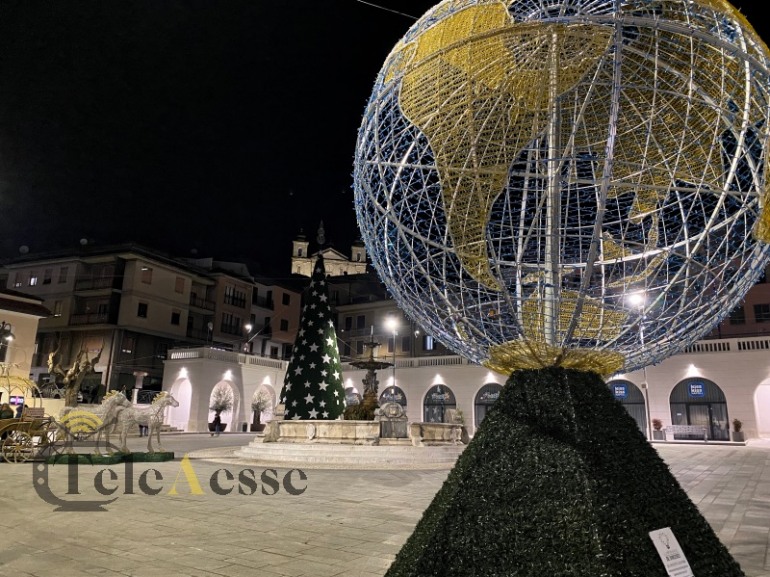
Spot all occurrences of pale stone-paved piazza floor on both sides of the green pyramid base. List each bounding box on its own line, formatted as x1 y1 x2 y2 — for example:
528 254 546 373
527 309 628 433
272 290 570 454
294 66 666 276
0 434 770 577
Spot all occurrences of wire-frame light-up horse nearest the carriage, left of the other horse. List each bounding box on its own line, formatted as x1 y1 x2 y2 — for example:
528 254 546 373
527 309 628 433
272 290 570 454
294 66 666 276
55 391 133 454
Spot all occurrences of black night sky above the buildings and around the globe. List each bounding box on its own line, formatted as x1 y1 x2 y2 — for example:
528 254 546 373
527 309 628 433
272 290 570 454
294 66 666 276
0 0 770 275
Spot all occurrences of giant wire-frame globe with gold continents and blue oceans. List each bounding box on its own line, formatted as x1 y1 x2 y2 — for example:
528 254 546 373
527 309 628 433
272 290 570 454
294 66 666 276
354 0 770 374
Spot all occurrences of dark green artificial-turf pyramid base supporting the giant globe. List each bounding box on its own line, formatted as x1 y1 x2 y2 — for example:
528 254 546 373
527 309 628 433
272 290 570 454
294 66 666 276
386 368 744 577
